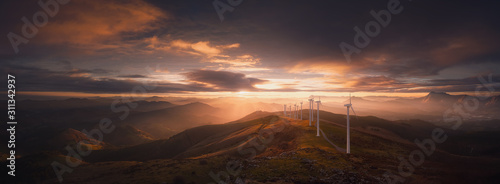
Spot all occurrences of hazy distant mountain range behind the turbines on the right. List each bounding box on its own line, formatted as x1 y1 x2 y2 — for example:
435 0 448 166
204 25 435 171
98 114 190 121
323 92 500 124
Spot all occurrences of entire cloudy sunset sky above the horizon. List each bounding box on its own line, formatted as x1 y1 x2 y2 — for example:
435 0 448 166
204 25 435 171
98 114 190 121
0 0 500 97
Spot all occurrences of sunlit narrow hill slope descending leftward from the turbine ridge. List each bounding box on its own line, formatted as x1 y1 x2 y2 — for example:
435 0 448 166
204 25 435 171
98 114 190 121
84 116 284 162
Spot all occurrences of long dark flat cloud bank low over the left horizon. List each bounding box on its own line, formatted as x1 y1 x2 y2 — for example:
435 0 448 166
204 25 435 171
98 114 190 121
1 63 205 93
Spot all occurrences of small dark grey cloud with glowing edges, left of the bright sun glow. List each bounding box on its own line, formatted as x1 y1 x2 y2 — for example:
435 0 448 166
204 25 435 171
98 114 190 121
184 70 267 91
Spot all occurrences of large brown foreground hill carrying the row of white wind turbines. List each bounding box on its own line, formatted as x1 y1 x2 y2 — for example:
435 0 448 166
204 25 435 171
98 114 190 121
41 111 500 183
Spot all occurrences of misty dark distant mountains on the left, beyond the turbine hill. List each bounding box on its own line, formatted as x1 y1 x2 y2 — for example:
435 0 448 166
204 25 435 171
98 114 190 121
0 98 230 154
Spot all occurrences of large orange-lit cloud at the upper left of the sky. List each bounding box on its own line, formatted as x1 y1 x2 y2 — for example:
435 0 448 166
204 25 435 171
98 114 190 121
39 0 168 49
